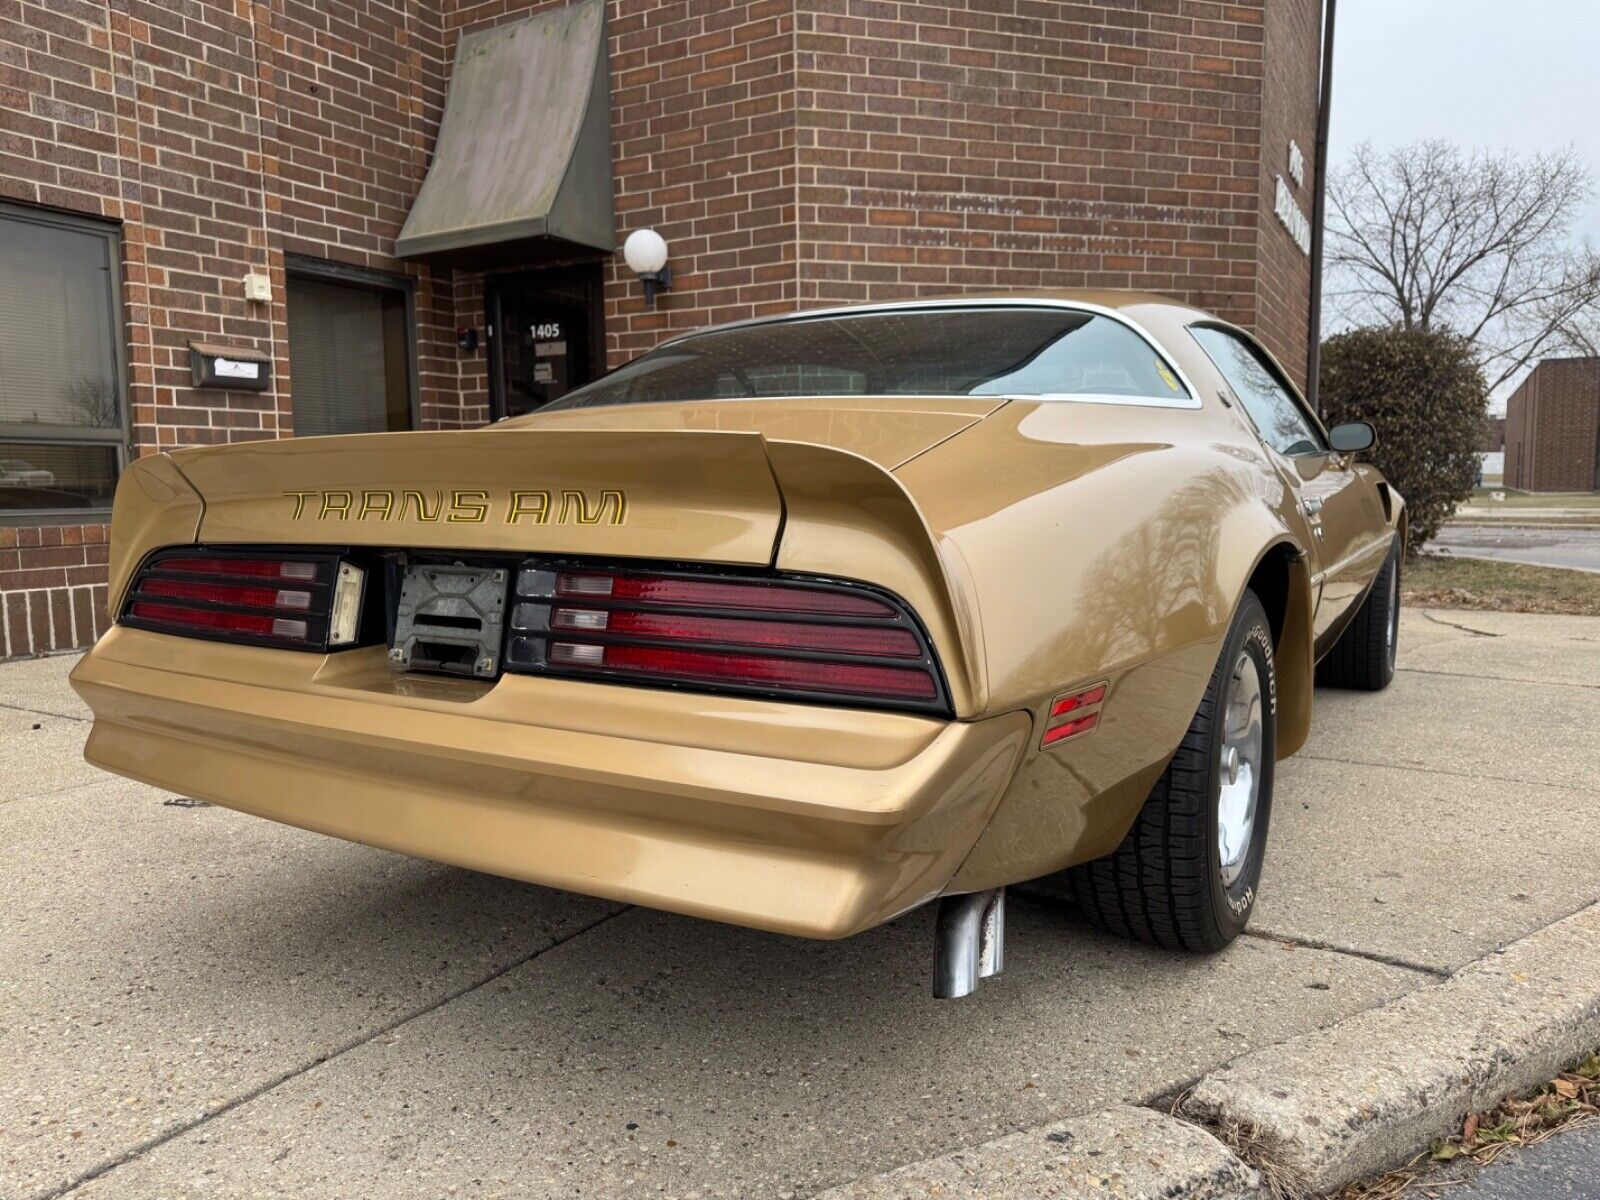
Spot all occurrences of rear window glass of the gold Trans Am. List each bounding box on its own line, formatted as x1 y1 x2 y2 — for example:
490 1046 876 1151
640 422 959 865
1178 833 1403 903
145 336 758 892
542 307 1190 411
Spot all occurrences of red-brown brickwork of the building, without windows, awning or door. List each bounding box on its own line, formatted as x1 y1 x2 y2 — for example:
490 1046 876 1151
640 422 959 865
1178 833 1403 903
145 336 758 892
0 0 1317 654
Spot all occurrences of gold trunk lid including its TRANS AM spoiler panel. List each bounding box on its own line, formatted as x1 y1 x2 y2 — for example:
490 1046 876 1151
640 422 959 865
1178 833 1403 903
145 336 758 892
171 398 1003 565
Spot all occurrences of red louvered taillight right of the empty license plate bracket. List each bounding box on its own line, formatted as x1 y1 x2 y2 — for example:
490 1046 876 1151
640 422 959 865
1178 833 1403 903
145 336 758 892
506 566 949 712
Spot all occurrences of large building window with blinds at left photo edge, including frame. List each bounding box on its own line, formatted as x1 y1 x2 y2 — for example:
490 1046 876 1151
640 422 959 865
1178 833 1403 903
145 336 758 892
0 205 126 522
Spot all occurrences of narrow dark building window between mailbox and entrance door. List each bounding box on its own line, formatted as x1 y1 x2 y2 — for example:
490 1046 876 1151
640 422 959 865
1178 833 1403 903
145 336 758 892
288 261 416 437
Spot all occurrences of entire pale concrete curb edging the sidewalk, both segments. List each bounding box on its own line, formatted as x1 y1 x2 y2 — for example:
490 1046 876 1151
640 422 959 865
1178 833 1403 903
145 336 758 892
818 904 1600 1200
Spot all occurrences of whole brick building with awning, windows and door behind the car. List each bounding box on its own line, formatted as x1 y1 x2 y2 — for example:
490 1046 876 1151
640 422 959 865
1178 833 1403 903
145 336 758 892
0 0 1324 658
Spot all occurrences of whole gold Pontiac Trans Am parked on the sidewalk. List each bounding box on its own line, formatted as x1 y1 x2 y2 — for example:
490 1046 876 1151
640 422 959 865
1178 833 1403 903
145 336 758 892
72 293 1406 995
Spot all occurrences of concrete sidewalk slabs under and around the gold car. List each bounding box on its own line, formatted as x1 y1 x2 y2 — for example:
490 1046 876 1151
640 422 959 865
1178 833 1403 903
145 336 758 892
0 610 1600 1197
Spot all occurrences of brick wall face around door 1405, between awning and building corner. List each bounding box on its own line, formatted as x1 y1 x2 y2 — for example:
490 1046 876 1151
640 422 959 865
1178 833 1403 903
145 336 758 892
445 0 798 374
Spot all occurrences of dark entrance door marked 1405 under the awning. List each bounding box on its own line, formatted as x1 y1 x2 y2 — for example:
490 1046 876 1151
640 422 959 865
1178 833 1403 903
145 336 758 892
488 264 605 421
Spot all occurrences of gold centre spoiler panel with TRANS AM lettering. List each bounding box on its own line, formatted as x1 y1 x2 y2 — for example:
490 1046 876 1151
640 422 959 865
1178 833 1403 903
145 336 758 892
173 429 782 563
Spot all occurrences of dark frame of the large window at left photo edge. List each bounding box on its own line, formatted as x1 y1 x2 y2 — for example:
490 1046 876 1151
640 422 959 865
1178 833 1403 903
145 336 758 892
0 200 133 526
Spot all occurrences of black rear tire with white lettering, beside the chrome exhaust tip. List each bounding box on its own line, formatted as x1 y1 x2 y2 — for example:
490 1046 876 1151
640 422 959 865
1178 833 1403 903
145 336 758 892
1064 590 1277 952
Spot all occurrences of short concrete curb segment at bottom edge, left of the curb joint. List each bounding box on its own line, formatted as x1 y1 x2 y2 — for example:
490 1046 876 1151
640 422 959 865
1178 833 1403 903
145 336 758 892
816 1106 1266 1200
